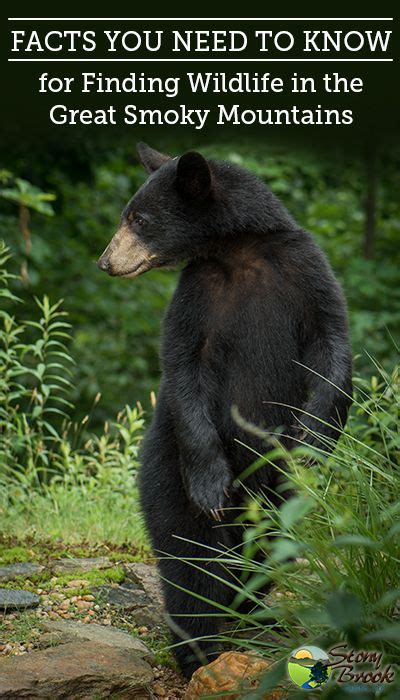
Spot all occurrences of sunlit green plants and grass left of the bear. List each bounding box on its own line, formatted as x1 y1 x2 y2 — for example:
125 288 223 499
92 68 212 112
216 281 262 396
0 244 147 542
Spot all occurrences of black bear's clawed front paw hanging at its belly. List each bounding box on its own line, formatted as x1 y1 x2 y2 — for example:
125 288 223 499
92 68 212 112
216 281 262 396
188 458 233 521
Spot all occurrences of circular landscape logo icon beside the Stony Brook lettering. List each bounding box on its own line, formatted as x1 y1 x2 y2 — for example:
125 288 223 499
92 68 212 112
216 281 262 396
288 645 332 690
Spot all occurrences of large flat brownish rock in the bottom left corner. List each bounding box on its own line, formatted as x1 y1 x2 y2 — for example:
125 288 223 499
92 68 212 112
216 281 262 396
0 642 153 700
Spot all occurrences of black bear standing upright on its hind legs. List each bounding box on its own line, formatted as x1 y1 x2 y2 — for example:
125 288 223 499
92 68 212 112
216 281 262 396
98 144 351 676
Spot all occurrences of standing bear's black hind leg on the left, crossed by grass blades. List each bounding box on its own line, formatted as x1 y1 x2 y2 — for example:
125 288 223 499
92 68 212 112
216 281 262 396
140 406 236 677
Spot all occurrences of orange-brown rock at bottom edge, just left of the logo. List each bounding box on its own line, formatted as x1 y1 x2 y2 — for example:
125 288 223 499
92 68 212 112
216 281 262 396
185 651 281 700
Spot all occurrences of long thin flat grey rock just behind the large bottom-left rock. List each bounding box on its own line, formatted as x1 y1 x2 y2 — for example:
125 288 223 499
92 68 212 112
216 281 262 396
39 620 154 663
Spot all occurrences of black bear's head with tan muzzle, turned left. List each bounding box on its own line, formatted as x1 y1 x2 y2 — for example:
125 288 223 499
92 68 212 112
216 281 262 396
98 143 215 277
